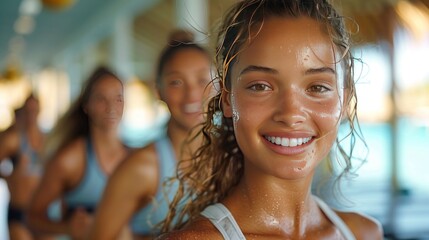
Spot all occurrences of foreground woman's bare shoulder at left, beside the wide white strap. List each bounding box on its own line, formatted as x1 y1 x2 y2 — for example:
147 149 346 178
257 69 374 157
157 217 223 240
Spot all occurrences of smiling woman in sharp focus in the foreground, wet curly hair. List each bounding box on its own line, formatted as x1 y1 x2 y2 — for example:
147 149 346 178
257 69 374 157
161 0 382 239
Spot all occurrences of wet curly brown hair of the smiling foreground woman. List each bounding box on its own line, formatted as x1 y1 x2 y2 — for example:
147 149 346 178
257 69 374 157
162 0 356 231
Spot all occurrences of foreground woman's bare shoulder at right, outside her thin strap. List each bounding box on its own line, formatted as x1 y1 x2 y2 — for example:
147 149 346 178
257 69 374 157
337 211 383 240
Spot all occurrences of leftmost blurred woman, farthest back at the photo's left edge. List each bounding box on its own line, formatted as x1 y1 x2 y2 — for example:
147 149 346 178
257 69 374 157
0 95 51 240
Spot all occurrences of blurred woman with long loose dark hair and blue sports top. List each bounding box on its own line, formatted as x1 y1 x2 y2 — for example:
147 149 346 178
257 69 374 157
29 67 129 239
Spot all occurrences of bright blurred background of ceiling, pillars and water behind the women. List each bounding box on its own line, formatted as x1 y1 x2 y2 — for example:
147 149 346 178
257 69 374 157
0 0 429 239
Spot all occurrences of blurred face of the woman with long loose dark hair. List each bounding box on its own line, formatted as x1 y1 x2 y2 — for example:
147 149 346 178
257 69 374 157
84 75 124 130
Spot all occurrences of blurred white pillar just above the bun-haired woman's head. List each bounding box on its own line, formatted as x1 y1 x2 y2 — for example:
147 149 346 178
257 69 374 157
176 0 209 44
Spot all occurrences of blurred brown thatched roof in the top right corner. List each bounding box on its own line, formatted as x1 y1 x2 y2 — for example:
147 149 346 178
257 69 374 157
333 0 429 44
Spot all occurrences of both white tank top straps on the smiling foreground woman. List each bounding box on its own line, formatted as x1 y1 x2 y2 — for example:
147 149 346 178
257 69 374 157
201 196 356 240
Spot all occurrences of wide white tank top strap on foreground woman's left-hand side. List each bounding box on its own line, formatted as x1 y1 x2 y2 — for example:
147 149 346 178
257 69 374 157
201 203 246 240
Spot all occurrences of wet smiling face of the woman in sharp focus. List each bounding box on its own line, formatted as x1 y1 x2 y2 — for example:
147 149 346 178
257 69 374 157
222 17 344 179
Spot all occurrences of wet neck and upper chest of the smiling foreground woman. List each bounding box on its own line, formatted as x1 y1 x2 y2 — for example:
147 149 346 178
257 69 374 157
225 166 321 238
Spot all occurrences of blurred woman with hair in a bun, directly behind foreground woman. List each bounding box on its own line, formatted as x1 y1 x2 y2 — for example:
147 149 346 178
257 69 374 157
90 30 211 240
